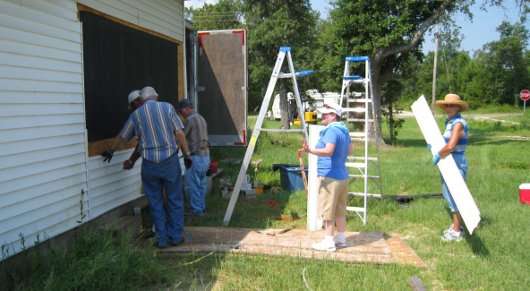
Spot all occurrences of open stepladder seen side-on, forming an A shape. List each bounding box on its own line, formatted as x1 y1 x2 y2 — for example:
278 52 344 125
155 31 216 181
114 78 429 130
223 46 314 226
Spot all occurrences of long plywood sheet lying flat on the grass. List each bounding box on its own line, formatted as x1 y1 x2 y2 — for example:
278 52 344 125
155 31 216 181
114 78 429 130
164 227 426 267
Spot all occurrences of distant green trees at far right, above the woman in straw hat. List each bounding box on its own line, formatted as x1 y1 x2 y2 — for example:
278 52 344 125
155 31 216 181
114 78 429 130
399 22 530 108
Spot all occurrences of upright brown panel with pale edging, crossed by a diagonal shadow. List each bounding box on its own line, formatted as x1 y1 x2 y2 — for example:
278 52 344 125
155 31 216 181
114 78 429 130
198 30 247 146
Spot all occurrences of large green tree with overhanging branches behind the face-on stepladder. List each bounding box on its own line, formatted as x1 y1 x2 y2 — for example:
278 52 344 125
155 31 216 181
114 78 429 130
314 0 469 141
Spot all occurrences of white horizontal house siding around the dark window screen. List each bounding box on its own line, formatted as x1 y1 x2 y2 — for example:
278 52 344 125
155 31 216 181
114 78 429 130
0 0 184 260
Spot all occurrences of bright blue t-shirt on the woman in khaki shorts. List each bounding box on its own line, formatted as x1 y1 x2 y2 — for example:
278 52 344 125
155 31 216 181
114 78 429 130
315 122 351 180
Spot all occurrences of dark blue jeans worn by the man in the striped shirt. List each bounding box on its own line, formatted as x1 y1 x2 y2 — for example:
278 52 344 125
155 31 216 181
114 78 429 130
142 154 184 246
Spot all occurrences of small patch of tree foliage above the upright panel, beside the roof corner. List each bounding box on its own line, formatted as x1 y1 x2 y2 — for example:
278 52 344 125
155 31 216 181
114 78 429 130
185 0 243 30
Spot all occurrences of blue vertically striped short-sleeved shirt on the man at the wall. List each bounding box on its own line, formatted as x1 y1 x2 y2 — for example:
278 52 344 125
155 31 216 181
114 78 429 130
120 100 184 163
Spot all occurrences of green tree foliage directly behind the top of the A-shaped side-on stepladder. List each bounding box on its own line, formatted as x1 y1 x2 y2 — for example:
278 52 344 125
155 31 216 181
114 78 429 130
243 0 318 113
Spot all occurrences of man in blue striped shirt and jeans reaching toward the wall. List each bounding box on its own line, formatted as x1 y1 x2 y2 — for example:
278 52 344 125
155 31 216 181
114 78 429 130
104 87 192 248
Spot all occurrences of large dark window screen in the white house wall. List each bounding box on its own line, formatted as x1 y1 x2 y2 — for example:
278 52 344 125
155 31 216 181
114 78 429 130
81 12 178 142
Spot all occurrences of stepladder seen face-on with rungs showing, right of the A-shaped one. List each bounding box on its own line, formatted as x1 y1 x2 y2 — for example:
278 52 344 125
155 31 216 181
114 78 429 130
340 56 383 224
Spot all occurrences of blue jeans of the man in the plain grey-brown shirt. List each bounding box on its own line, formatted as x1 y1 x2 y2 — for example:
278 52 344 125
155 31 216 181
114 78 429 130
184 155 210 214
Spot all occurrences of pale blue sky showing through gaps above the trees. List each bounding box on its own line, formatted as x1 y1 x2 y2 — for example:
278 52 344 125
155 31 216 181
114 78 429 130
184 0 530 55
